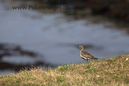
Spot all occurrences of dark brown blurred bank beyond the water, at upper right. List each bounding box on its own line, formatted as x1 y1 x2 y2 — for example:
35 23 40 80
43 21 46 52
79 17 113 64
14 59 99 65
43 0 129 22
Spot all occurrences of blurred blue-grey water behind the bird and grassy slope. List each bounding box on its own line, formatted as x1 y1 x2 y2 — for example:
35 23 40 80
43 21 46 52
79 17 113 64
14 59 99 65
0 1 129 74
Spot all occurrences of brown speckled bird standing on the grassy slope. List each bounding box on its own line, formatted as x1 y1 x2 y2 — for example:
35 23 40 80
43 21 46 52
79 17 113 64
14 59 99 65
79 45 98 61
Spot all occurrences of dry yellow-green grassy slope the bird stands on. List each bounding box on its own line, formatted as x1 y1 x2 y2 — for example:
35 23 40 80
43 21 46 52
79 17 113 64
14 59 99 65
0 55 129 86
